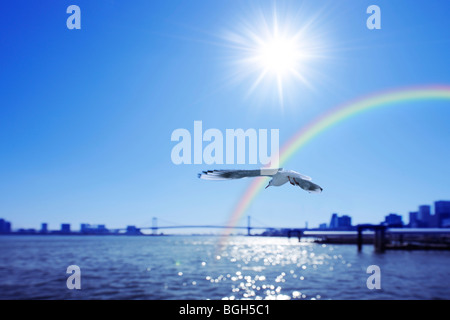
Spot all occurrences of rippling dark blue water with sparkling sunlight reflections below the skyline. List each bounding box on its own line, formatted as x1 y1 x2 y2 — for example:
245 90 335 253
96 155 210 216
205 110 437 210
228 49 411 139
0 235 450 300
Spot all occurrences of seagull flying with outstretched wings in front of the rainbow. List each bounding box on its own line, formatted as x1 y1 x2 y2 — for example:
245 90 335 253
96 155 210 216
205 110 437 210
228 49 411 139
198 168 323 193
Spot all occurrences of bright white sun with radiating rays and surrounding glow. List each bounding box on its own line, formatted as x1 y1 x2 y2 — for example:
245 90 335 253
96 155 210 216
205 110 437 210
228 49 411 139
221 5 323 106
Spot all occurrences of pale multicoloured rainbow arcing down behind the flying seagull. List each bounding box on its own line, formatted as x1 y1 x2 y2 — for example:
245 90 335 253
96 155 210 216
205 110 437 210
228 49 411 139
216 85 450 245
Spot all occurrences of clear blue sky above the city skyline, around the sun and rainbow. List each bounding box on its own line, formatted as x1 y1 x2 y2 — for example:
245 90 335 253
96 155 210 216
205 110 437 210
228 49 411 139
0 0 450 229
